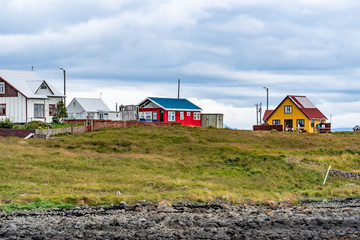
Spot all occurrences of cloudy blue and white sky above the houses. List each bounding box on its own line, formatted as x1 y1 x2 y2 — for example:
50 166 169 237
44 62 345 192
0 0 360 129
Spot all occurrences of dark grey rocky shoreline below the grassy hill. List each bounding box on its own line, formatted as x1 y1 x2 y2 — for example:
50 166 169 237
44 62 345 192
0 198 360 239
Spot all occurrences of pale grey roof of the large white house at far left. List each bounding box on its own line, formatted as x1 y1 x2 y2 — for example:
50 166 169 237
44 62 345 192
0 69 64 98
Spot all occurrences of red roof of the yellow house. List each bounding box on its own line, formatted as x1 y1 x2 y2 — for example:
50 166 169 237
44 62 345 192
263 95 327 121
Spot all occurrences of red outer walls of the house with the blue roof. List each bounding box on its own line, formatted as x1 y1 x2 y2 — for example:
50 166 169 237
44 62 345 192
139 108 201 126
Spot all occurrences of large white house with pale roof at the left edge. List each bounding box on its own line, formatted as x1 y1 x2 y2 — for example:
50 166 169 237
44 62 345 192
0 70 64 124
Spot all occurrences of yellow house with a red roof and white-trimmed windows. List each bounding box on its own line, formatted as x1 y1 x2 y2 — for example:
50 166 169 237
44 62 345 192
263 95 330 133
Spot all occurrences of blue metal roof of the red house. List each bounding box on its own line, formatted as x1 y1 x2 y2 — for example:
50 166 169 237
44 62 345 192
148 97 202 111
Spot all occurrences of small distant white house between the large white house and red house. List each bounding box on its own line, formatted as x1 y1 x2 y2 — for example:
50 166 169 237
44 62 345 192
66 98 120 120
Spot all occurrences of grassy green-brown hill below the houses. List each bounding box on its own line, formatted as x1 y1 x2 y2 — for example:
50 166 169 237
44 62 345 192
0 126 360 204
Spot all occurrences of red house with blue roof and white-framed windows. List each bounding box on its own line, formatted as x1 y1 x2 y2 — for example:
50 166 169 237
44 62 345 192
139 97 202 126
